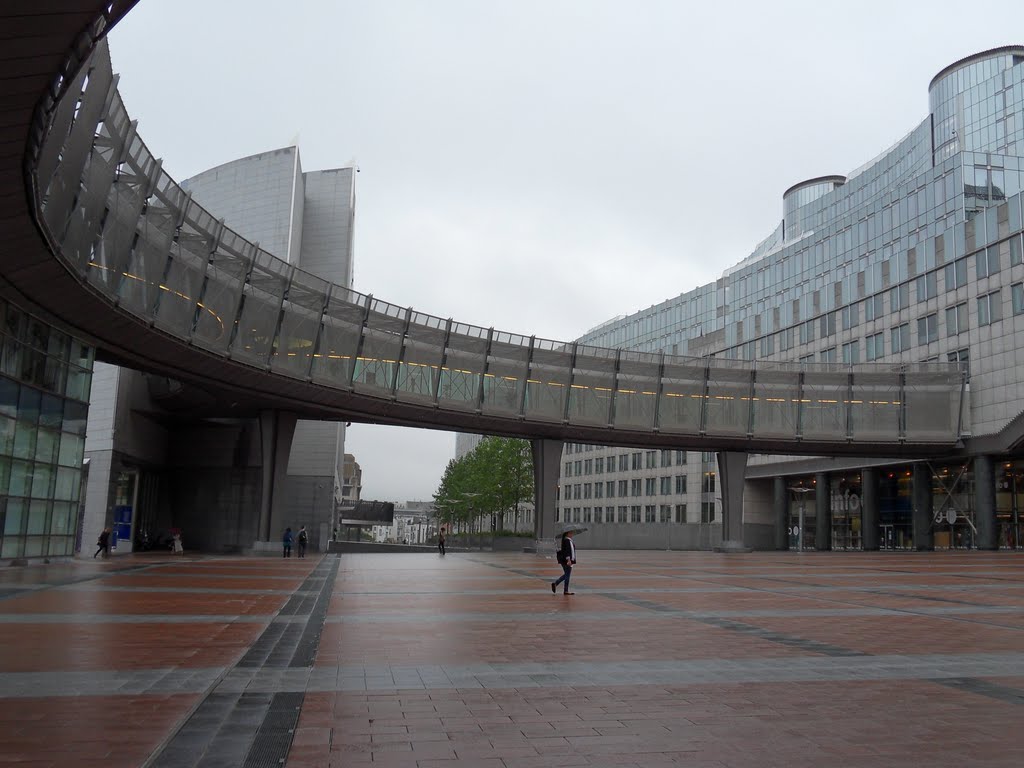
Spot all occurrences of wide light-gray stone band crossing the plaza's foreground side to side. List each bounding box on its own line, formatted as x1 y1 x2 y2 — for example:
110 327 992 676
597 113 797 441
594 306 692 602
8 652 1024 697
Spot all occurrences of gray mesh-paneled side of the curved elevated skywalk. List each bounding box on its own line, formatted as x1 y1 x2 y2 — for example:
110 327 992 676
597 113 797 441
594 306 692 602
27 16 967 455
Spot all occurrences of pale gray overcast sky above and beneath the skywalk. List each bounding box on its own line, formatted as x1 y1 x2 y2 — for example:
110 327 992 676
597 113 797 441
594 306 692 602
111 0 1024 501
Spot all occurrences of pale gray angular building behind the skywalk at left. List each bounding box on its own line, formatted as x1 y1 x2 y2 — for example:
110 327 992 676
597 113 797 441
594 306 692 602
85 146 357 551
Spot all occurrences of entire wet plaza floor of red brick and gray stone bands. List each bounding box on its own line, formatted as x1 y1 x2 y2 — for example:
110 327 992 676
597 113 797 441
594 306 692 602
0 540 1024 768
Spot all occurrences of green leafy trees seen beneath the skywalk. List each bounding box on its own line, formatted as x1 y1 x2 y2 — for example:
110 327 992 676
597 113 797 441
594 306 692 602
434 437 534 532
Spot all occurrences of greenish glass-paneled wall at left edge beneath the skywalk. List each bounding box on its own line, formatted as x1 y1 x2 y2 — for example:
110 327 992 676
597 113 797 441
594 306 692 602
0 302 93 559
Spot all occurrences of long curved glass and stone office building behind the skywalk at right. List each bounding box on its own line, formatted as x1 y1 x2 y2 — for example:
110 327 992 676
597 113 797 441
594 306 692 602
559 46 1024 549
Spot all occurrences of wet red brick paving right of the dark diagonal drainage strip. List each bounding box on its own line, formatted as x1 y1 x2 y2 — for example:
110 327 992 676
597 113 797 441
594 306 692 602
288 552 1024 768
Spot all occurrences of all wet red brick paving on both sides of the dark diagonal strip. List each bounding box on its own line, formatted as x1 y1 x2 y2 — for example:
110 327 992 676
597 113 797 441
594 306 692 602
0 551 1024 768
